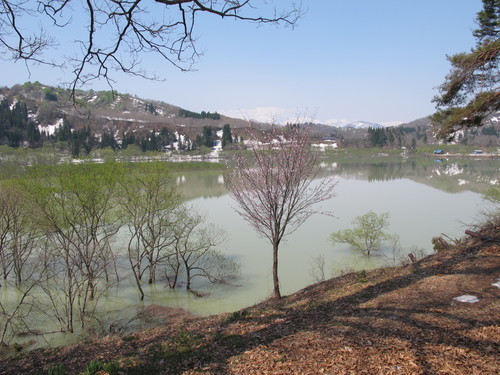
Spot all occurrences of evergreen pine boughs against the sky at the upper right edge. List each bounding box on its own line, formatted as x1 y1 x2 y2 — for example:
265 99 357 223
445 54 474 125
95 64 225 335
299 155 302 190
433 0 500 138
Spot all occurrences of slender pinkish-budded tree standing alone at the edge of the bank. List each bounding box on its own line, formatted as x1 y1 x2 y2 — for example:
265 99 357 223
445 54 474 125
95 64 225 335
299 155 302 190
226 128 336 298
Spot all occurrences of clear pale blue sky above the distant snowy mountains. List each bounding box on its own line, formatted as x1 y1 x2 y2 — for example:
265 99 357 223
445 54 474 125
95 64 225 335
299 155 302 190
0 0 482 125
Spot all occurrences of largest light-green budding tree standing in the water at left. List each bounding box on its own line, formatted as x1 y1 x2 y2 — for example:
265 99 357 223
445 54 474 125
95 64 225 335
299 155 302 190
24 164 121 332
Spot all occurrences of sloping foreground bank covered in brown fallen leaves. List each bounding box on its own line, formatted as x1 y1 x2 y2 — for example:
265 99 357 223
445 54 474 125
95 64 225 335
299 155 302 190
0 223 500 374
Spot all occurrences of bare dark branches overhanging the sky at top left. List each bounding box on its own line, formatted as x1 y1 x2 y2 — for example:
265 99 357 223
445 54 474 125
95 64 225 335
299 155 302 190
0 0 303 92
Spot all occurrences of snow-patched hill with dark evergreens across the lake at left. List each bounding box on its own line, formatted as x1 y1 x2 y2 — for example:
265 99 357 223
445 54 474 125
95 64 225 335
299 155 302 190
0 82 258 155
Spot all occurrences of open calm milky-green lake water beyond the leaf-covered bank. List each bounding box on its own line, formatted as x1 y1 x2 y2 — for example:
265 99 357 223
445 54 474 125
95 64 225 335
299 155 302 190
0 158 500 344
